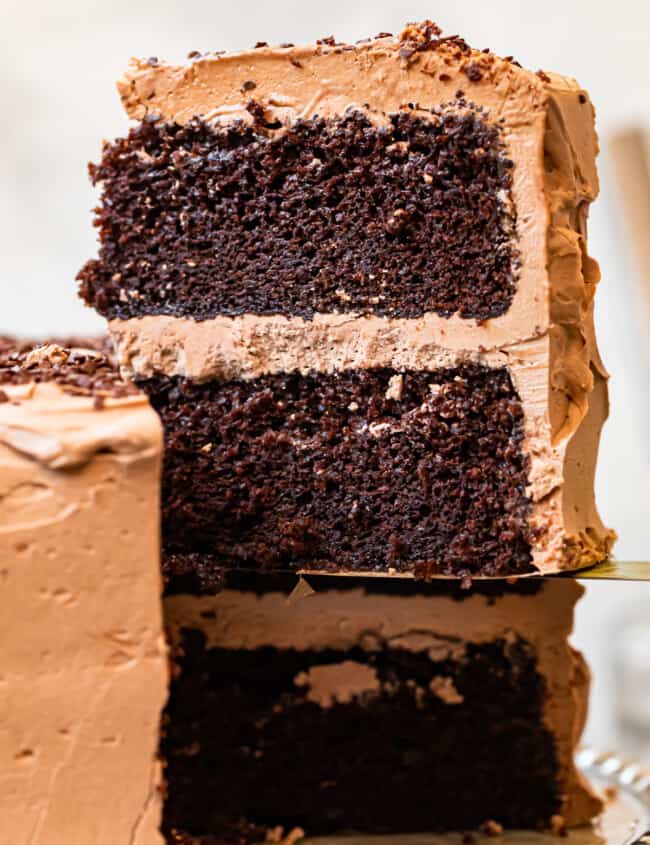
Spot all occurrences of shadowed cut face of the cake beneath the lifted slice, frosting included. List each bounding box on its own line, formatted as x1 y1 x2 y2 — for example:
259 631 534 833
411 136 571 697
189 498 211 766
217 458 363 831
161 581 600 845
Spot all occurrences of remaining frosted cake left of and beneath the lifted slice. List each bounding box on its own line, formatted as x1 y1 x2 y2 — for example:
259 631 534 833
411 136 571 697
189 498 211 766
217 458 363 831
0 339 601 845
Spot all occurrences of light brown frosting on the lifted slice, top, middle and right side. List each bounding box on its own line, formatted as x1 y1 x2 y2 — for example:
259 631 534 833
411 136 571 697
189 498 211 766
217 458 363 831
102 25 614 572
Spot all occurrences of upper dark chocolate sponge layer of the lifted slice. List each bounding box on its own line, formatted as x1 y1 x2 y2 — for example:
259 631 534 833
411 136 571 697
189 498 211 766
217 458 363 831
80 109 517 319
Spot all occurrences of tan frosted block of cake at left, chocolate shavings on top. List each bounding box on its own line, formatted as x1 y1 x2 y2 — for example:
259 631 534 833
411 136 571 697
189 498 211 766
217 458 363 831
0 339 167 845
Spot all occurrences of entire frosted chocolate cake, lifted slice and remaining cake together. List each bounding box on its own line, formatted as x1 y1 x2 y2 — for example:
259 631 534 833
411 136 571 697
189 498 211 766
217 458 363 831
0 11 624 845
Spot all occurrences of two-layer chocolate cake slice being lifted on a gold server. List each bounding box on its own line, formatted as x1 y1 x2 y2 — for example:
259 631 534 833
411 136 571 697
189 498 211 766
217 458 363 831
80 22 613 589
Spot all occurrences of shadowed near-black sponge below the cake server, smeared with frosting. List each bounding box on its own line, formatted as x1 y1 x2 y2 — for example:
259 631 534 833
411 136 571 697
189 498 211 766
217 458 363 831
161 631 560 842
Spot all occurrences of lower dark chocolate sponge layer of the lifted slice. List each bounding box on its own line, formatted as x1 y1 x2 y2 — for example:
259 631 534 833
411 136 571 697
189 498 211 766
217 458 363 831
141 364 531 586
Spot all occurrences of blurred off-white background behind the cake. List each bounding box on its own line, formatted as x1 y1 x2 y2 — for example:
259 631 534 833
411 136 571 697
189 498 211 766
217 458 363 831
0 0 650 761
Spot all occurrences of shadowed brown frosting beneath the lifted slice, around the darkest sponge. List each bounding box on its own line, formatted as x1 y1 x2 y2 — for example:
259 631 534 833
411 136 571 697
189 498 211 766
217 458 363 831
165 581 601 825
